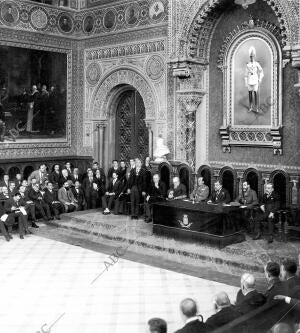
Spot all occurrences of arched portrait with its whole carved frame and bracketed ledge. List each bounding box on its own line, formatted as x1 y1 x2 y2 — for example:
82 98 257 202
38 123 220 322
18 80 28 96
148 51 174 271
219 26 282 154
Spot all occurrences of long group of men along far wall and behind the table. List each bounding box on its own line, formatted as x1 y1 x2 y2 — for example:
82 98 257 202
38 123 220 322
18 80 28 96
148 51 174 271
0 158 279 242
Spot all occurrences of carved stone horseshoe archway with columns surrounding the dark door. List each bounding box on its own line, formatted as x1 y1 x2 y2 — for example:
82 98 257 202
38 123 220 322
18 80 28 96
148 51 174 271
89 67 158 167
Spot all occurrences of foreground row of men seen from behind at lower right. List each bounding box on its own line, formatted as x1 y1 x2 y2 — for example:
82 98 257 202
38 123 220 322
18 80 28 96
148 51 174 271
148 256 300 333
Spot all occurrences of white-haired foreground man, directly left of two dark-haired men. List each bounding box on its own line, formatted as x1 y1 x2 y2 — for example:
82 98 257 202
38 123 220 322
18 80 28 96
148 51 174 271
236 273 266 315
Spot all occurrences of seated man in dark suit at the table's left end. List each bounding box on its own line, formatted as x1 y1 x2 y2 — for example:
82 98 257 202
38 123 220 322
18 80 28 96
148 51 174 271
145 173 167 223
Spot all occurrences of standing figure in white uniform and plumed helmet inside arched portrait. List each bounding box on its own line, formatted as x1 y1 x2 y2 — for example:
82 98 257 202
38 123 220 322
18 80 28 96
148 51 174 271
245 46 264 113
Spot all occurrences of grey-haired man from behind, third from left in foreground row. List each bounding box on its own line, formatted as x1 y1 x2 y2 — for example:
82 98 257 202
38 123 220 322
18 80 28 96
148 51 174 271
205 291 239 330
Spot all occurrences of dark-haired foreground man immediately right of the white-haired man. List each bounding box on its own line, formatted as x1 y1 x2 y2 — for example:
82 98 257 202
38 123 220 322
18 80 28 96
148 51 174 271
265 262 289 303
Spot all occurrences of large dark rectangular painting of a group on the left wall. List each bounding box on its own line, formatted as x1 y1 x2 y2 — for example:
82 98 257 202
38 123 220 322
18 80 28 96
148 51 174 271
0 45 71 146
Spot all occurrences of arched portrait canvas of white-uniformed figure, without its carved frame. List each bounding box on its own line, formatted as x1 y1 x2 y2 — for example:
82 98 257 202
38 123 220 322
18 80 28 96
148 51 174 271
231 38 274 126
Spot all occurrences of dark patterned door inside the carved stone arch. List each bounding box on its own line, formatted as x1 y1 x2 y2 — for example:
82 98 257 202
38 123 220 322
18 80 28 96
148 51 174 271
115 88 149 161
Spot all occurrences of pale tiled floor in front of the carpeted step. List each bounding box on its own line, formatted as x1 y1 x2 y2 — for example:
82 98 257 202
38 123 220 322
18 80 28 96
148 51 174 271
0 235 237 333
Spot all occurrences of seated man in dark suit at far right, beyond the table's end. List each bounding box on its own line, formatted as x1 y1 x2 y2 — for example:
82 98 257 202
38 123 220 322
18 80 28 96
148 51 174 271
253 183 280 243
